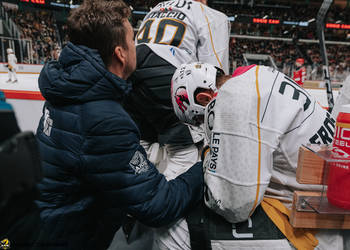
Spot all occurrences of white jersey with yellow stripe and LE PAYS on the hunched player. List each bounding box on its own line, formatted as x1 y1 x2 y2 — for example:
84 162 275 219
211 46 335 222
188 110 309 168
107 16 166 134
204 66 335 223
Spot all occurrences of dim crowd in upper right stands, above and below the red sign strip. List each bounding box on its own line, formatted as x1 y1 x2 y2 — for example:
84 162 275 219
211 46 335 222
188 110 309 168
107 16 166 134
214 1 350 41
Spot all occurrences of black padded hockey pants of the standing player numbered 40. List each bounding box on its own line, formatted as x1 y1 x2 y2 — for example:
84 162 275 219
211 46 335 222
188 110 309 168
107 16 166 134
124 44 193 145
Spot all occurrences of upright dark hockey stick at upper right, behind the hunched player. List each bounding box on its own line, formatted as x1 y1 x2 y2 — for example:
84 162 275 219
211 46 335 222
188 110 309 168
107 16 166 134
316 0 334 112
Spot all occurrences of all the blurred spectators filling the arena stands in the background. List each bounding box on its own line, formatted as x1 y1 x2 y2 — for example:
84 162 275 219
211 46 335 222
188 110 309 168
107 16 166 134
0 0 350 81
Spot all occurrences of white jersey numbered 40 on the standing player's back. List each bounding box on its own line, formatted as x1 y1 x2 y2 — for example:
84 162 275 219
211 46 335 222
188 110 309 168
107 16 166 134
135 0 230 74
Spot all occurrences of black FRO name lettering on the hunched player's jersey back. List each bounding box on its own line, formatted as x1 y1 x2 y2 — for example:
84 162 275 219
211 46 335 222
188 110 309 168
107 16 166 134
309 112 335 144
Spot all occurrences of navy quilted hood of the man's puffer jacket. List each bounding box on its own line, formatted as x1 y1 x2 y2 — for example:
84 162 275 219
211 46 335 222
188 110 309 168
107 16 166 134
39 43 131 104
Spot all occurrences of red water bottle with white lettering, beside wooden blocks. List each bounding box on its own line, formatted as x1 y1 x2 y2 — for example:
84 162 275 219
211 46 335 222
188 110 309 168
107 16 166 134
327 105 350 209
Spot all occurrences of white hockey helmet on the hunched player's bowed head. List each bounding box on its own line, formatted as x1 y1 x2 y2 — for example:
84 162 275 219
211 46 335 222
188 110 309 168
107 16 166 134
171 62 220 126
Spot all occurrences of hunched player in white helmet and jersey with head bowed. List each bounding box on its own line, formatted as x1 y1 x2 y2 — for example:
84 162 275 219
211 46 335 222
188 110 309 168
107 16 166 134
171 63 343 250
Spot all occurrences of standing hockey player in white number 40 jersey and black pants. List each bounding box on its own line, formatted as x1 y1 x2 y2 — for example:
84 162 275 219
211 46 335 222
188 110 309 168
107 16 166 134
125 0 230 179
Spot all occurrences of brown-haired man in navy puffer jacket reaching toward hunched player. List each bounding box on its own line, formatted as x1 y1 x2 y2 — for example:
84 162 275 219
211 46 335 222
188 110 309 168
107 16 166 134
34 0 203 250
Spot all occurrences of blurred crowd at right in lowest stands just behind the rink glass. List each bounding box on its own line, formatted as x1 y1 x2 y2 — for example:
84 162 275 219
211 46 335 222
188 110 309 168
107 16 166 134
230 38 350 81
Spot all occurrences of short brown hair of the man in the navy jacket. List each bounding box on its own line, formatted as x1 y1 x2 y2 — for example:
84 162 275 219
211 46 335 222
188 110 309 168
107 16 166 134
67 0 131 67
